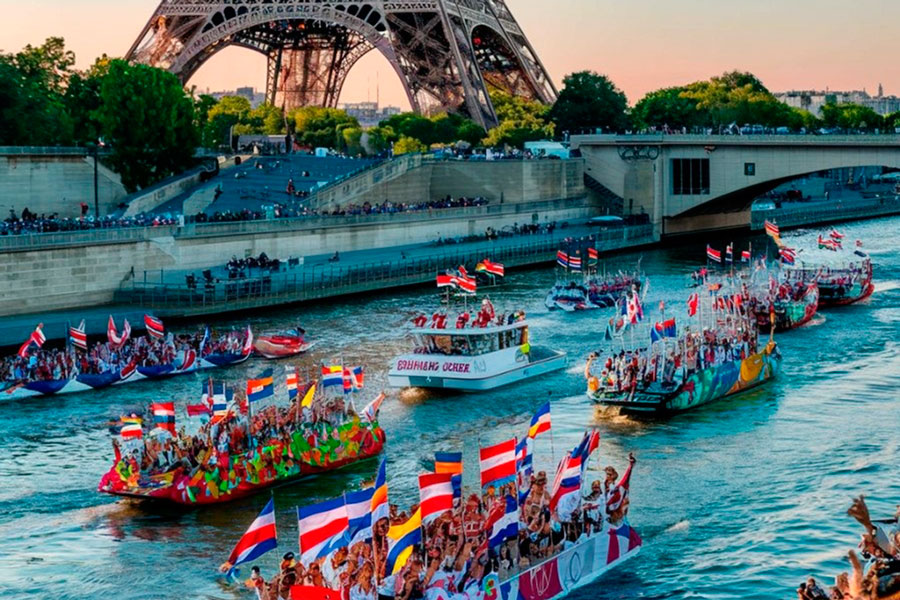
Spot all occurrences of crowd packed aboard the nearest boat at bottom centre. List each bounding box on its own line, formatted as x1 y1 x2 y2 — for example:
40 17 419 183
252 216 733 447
236 455 635 600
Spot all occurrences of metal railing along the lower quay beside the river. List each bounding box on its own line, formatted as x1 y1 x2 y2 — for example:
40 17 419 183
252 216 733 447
116 225 654 316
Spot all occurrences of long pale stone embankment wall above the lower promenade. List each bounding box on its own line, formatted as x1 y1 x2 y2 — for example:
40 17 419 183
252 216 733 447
0 199 594 315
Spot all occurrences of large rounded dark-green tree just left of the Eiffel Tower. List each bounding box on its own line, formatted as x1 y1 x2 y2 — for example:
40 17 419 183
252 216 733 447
96 60 199 191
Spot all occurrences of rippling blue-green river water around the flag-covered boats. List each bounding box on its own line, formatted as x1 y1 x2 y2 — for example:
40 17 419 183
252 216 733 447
0 218 900 600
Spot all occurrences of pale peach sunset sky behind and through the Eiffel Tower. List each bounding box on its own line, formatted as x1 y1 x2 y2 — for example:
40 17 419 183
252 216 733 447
0 0 900 107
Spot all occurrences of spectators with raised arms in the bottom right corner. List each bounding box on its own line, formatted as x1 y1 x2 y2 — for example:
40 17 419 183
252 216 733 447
797 496 900 600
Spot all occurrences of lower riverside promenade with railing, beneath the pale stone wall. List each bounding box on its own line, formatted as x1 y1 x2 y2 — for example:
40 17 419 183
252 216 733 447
0 220 655 346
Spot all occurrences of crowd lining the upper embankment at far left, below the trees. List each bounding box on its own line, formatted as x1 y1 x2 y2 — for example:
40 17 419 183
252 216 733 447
0 205 179 235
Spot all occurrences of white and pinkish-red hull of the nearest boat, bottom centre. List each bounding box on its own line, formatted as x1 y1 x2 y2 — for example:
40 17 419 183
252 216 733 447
497 524 643 600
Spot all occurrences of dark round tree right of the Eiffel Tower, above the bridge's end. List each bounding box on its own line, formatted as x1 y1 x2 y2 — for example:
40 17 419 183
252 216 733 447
550 71 628 133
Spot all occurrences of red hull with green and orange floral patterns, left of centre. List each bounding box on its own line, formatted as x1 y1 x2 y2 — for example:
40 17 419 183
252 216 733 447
97 421 385 506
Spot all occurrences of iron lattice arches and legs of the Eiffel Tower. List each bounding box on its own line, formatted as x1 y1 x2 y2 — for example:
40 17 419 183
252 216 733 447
127 0 556 128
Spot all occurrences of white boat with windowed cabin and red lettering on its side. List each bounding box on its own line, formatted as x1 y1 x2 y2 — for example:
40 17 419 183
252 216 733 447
388 320 566 392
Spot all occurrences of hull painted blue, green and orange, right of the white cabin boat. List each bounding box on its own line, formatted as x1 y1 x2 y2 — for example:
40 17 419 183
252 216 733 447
588 343 781 416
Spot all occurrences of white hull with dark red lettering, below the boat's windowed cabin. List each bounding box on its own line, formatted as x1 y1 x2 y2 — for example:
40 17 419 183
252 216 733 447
388 346 567 392
